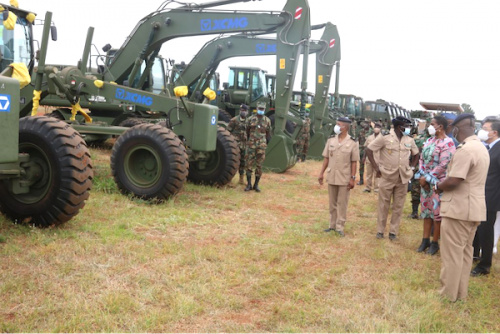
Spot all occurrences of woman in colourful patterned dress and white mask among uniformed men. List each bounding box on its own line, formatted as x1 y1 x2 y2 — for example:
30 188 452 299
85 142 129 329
415 116 455 255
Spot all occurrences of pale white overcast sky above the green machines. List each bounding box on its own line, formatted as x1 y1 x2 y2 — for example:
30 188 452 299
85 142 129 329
19 0 500 119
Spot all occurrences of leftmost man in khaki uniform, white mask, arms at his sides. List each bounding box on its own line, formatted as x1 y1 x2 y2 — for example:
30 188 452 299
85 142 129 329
318 117 359 237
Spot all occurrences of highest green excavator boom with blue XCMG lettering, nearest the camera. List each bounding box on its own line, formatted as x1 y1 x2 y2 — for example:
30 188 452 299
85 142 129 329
104 0 309 87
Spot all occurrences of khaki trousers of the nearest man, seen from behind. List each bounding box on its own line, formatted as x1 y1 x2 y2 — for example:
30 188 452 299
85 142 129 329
439 217 479 302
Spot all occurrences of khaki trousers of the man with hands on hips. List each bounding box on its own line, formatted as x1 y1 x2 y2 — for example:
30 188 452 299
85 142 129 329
377 178 408 235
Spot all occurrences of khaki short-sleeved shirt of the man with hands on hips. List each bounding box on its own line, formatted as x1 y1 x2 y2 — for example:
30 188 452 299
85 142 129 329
368 129 419 183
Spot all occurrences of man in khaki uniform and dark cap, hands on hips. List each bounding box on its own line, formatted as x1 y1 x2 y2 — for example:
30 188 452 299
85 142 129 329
366 116 419 241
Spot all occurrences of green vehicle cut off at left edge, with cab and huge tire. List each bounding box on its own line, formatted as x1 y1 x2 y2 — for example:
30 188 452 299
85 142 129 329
0 3 93 227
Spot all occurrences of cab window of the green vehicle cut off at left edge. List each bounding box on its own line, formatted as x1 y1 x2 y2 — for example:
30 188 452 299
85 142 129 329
0 15 32 71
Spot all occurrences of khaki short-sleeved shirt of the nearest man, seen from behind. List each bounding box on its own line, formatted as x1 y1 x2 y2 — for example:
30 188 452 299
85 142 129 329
441 135 490 222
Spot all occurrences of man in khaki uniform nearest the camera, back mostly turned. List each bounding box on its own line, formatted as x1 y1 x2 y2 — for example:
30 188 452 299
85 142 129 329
435 114 490 302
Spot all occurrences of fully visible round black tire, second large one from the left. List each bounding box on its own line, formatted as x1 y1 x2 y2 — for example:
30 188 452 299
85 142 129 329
111 123 188 201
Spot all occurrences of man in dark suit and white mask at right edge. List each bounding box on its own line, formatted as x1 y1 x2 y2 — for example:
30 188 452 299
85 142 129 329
471 118 500 276
